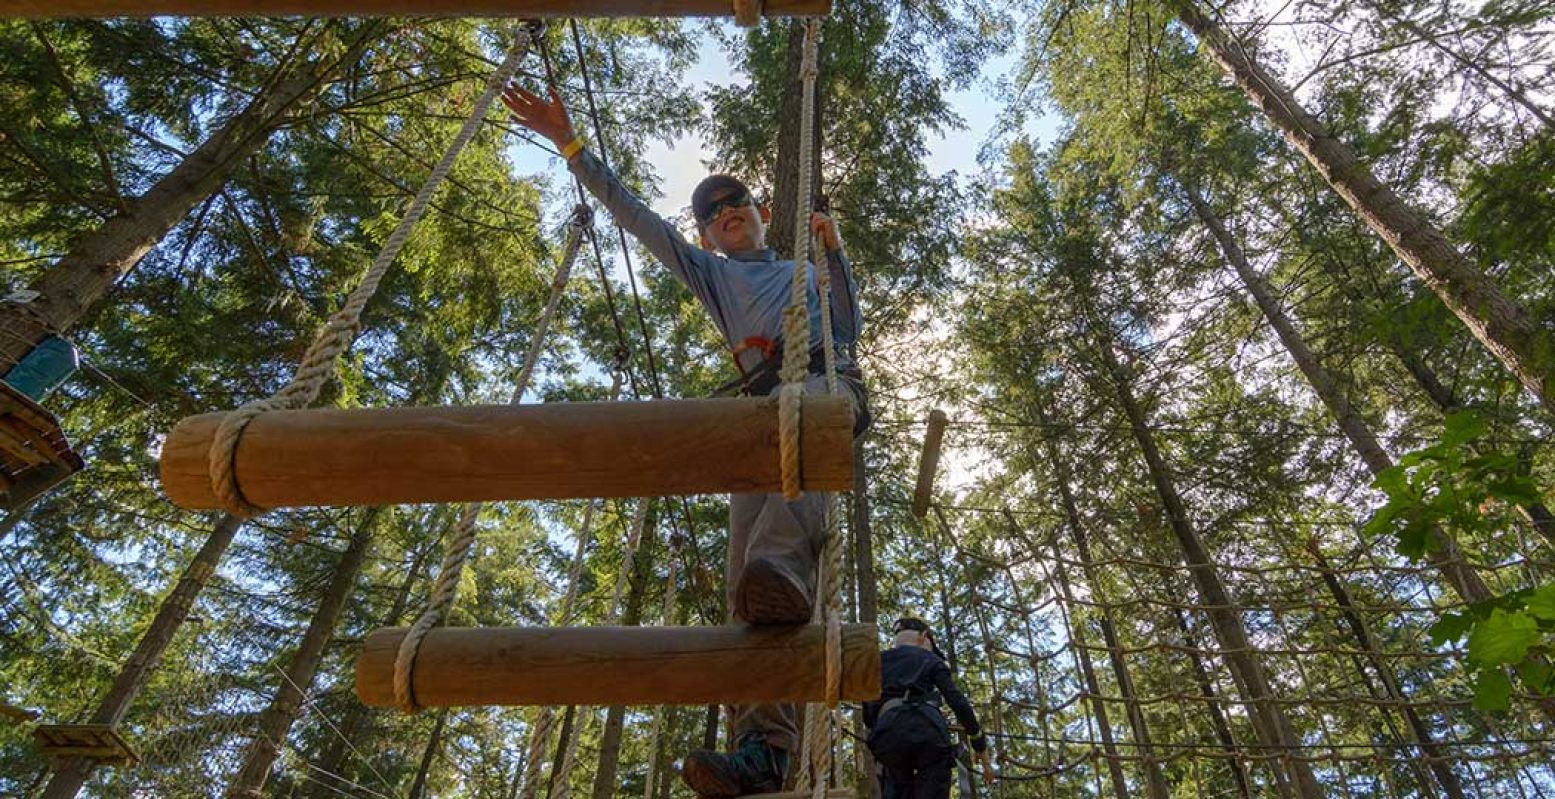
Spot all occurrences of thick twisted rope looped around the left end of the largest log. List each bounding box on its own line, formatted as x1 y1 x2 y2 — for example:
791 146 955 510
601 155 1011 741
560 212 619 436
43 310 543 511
210 26 538 518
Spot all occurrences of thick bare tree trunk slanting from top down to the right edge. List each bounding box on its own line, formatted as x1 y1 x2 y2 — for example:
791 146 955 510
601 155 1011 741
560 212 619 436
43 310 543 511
1171 0 1555 412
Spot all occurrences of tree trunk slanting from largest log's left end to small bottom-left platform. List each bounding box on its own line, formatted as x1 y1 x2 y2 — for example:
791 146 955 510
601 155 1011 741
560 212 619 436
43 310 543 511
42 513 243 799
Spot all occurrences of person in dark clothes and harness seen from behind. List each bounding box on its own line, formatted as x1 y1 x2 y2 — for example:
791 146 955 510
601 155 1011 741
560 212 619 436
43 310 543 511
865 619 994 799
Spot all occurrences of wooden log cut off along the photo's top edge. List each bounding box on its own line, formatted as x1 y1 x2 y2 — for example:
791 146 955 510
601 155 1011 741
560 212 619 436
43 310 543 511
0 0 832 19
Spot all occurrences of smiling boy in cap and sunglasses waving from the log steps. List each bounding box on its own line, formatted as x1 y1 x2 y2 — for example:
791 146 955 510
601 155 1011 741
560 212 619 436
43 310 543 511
504 85 868 797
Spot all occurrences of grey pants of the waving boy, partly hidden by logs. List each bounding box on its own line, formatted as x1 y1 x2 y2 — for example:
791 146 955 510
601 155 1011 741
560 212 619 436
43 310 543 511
723 375 863 752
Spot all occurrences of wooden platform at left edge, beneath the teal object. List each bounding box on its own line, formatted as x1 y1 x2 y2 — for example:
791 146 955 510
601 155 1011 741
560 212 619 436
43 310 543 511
0 381 84 511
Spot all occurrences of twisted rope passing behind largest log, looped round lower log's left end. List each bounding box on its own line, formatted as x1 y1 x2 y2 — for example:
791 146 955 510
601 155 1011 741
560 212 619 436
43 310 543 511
393 205 592 712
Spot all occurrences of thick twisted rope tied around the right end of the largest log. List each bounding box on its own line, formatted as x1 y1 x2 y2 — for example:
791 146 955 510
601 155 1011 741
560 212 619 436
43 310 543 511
778 19 821 502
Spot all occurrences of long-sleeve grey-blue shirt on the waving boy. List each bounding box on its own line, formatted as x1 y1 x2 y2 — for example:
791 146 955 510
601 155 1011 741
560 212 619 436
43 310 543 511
568 149 863 368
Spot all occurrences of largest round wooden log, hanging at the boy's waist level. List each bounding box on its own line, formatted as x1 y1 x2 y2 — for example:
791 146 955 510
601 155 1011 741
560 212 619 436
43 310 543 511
162 396 854 510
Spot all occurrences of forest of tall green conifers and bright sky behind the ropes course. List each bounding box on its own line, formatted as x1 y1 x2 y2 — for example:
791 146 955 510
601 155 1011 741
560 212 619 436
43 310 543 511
0 0 1555 799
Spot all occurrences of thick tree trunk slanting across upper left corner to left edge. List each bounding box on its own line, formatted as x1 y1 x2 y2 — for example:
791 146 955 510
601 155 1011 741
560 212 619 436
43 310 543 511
0 20 387 373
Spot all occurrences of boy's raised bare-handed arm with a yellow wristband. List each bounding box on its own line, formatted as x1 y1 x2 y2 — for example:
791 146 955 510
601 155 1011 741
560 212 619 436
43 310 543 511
502 84 714 295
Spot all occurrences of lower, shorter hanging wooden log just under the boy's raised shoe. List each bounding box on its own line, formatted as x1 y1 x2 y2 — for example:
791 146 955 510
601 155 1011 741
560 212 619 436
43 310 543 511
356 625 880 707
